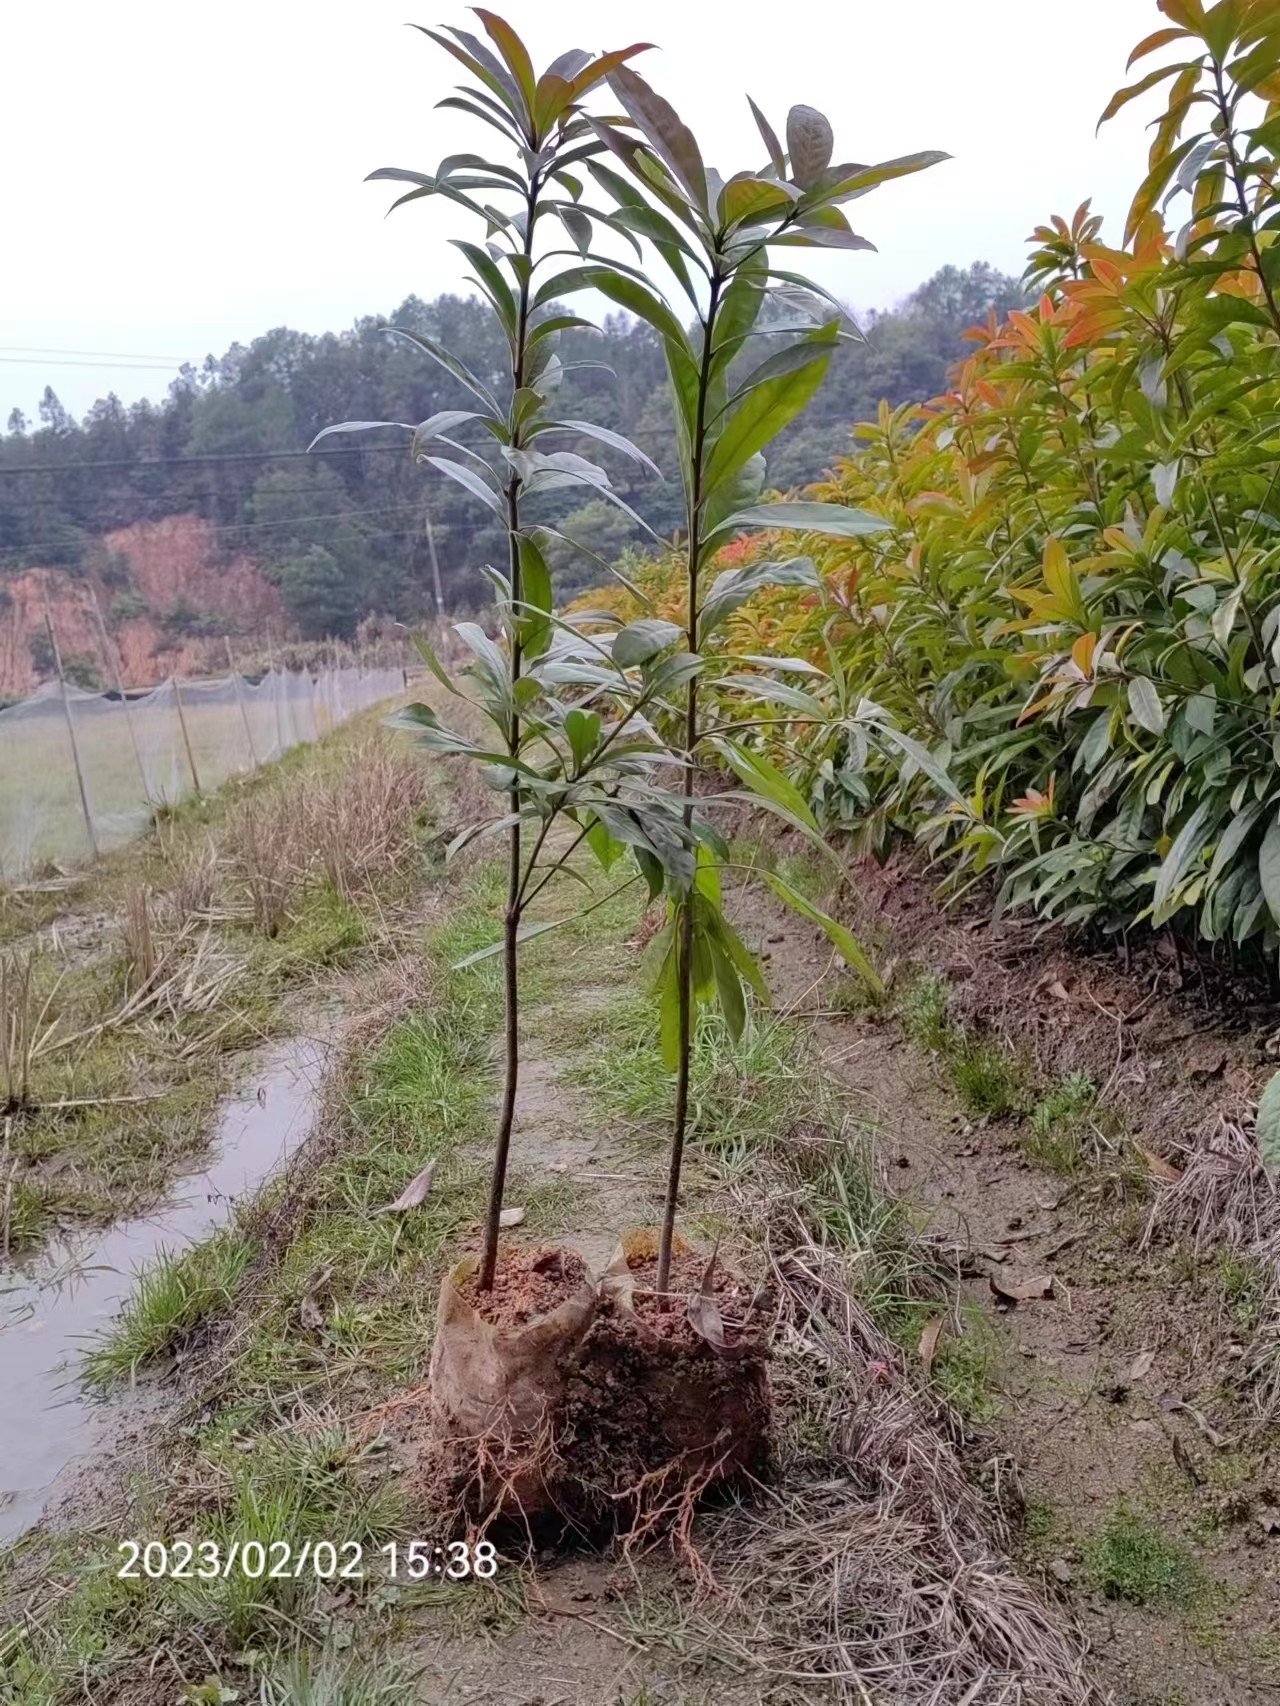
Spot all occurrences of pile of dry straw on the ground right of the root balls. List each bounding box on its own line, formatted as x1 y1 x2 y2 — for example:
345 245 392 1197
675 1215 1103 1706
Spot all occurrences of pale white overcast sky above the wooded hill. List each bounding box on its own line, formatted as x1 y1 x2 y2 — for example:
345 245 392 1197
0 0 1161 421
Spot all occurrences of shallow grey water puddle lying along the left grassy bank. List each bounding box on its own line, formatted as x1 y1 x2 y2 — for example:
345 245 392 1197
0 1039 324 1542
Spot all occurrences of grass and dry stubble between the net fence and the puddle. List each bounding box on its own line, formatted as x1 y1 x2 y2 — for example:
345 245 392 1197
0 718 427 1252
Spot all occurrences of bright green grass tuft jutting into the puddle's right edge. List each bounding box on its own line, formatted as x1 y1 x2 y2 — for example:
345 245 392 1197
84 1227 254 1387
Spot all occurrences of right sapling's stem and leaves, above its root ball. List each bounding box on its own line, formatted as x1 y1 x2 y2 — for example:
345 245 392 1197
587 65 945 1291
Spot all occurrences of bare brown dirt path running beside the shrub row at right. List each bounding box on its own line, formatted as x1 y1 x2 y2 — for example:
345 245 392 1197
736 891 1280 1706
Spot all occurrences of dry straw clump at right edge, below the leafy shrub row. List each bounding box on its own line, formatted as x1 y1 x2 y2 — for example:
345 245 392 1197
1143 1114 1280 1425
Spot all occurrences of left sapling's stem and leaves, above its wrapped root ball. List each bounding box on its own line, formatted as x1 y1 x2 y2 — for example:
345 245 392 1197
312 9 713 1291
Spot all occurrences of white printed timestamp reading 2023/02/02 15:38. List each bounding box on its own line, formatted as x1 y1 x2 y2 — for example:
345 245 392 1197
116 1541 498 1581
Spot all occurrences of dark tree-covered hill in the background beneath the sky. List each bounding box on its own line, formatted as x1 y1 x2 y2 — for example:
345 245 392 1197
0 263 1021 635
